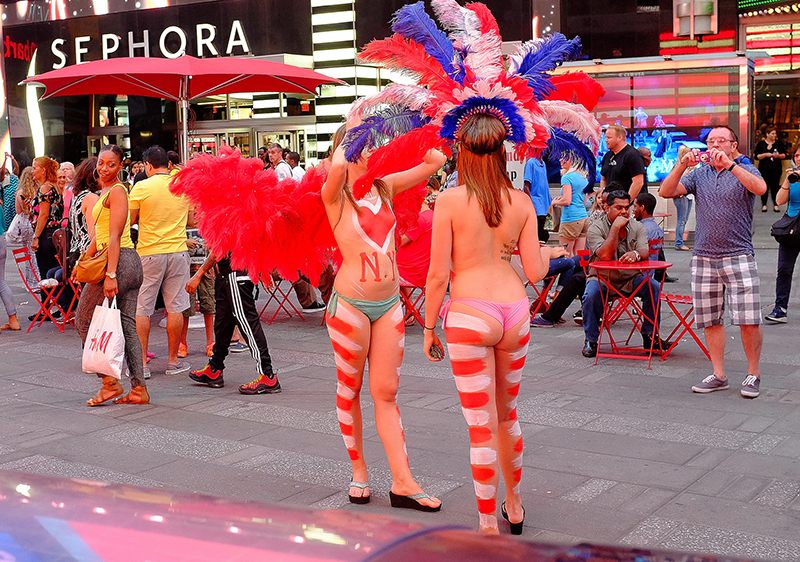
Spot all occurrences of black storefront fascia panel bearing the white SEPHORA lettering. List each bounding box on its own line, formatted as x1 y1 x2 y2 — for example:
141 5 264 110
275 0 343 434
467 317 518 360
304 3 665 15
3 0 312 76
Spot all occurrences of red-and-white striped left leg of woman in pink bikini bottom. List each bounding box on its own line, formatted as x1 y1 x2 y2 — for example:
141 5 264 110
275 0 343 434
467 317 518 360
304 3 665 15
445 311 499 529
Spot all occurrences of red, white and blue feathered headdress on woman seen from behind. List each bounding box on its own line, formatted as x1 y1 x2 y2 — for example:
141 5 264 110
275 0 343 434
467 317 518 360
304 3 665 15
344 0 603 177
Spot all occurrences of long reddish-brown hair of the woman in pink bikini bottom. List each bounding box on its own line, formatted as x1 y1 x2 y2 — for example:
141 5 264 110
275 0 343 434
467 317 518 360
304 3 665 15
456 114 514 228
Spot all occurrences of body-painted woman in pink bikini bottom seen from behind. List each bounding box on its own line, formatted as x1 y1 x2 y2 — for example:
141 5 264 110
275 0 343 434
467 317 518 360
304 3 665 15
424 113 563 534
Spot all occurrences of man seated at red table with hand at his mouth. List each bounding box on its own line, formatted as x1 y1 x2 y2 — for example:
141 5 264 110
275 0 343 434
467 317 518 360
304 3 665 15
582 191 669 357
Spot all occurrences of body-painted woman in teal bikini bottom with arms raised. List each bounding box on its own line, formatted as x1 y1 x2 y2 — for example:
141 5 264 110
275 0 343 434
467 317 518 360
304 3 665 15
322 142 445 511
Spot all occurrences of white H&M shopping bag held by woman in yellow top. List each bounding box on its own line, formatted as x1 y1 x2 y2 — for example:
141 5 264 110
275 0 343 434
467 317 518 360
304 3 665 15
82 297 125 379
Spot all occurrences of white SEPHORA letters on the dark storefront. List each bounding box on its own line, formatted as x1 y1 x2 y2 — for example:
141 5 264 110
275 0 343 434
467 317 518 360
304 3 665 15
49 19 251 69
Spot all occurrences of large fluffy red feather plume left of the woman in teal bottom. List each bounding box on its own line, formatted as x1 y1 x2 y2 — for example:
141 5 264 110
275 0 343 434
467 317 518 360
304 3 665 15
170 147 336 283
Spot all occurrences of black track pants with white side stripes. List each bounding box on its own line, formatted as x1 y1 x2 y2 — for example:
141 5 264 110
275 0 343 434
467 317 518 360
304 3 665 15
209 271 273 378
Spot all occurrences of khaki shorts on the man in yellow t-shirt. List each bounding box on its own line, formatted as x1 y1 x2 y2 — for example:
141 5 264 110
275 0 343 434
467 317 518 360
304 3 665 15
136 252 189 317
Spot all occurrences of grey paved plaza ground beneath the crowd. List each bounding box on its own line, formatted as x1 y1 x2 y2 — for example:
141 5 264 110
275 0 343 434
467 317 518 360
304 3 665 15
0 212 800 560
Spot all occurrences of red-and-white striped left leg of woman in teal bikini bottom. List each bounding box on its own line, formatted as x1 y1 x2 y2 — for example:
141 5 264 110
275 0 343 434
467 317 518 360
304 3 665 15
327 304 369 461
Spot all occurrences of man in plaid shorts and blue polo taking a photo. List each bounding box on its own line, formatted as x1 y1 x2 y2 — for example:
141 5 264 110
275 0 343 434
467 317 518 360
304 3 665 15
659 127 767 398
